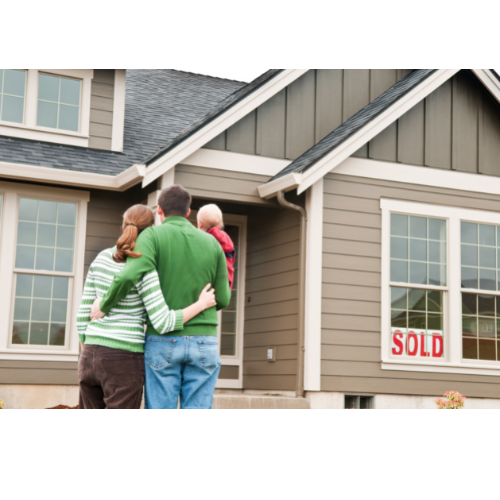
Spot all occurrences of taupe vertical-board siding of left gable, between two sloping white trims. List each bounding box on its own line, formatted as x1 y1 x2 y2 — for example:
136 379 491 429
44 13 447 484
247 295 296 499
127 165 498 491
204 69 412 160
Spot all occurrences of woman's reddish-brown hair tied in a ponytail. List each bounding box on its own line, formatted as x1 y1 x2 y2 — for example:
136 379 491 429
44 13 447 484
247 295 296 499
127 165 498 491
113 205 155 264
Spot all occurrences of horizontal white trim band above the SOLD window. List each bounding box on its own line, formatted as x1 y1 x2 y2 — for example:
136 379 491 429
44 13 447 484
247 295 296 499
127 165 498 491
331 158 500 195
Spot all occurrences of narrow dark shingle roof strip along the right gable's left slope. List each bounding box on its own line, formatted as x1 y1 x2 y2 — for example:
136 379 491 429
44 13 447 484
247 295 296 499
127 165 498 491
269 69 437 182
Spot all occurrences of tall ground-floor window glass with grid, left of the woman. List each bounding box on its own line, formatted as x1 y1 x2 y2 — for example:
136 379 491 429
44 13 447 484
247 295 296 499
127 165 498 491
12 198 77 346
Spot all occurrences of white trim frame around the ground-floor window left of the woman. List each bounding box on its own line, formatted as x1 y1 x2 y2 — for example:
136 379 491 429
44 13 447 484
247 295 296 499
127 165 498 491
0 182 90 361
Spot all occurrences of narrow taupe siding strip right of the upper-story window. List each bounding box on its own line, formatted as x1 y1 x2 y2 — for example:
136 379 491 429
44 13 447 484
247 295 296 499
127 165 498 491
89 69 115 151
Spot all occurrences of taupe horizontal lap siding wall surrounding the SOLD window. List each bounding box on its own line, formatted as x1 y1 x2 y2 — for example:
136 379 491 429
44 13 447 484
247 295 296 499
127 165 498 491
321 173 500 398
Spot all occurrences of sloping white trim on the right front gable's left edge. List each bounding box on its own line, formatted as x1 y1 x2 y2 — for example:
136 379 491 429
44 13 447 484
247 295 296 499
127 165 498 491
259 69 460 198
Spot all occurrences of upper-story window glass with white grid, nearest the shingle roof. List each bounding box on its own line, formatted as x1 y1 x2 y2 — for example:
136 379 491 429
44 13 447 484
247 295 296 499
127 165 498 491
37 74 81 132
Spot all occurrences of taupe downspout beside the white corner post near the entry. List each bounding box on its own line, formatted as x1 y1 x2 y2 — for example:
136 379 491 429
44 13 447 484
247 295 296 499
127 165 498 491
278 191 307 398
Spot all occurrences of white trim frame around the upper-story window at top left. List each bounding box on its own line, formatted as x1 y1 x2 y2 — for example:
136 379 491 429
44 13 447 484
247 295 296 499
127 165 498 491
0 69 94 147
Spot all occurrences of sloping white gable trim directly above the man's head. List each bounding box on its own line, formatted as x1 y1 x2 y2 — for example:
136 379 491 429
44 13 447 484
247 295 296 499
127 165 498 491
143 69 309 187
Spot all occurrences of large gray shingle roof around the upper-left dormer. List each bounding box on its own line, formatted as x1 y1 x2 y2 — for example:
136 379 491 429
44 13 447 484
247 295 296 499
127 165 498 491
0 69 245 175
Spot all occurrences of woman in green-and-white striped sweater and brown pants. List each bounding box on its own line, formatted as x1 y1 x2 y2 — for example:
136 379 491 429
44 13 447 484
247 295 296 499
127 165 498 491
77 205 216 410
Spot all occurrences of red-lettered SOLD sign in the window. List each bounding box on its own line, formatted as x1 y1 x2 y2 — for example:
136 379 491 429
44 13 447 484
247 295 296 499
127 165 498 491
391 328 444 358
